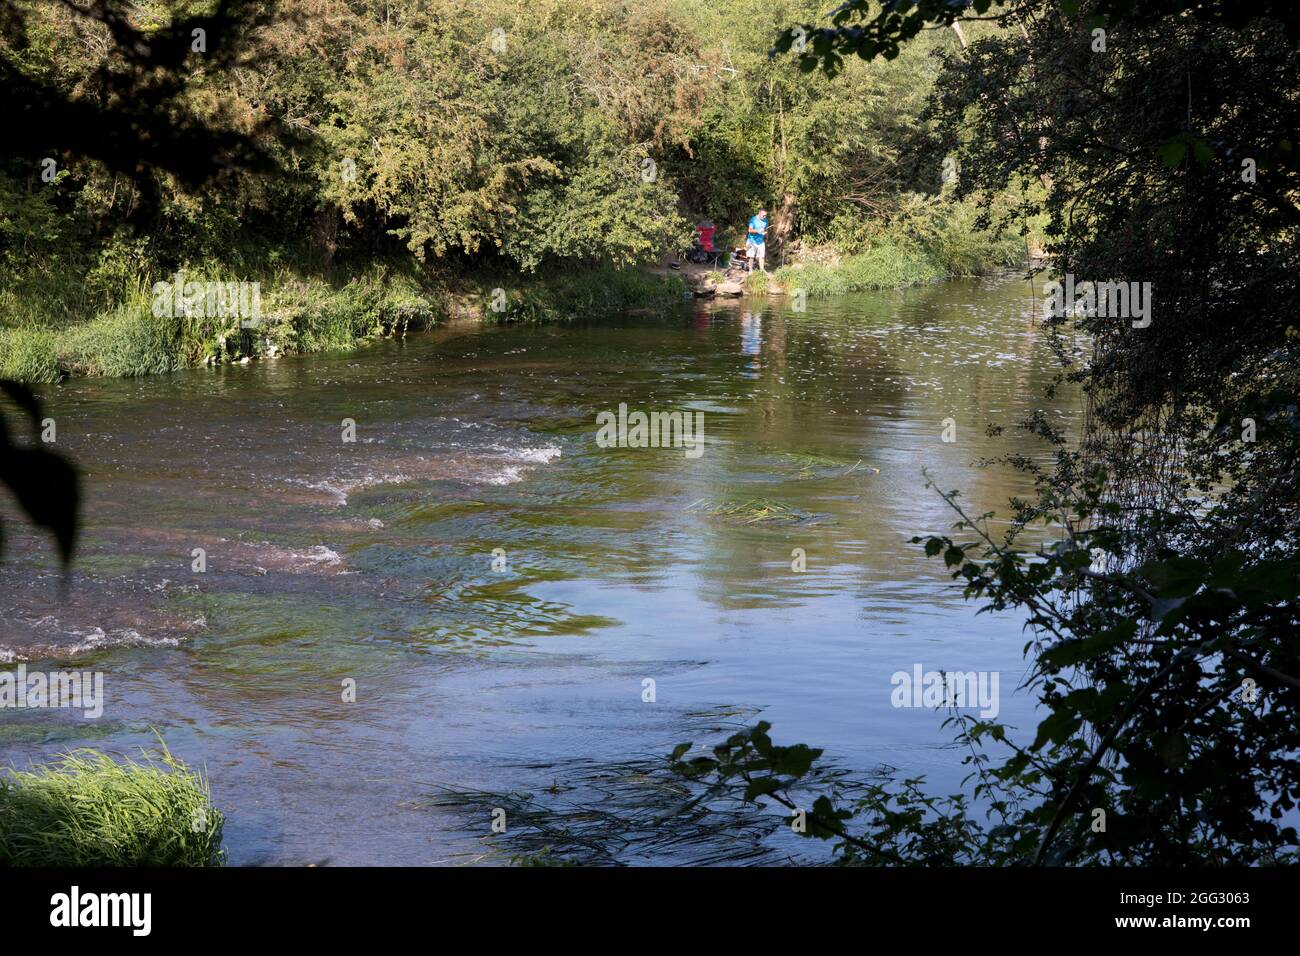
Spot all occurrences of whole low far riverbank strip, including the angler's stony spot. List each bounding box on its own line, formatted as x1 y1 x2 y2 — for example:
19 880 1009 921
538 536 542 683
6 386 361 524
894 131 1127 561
0 226 1027 384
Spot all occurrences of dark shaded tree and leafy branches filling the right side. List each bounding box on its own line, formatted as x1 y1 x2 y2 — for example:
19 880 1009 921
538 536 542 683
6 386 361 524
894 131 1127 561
660 0 1300 866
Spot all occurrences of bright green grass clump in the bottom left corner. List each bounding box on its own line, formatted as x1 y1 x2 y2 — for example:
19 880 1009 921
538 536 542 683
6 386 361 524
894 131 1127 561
0 747 225 866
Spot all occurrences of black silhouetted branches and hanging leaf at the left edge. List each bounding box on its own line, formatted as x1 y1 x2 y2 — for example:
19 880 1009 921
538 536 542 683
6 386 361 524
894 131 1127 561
0 0 273 566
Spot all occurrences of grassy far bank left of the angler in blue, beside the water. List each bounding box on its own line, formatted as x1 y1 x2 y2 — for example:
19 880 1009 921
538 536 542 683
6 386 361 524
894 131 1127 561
0 264 686 382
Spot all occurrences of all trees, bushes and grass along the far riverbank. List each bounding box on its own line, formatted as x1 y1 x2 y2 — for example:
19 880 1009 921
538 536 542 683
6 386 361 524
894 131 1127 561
0 0 1019 382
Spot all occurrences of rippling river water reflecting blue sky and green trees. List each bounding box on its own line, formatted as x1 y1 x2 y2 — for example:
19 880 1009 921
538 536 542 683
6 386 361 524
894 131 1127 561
0 280 1079 865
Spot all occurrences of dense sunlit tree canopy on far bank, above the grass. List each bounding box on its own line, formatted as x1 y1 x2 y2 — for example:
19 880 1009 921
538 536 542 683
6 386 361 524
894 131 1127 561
0 0 1024 287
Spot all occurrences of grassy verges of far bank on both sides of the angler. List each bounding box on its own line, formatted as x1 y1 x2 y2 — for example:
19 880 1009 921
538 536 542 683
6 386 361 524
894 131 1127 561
0 202 1026 382
